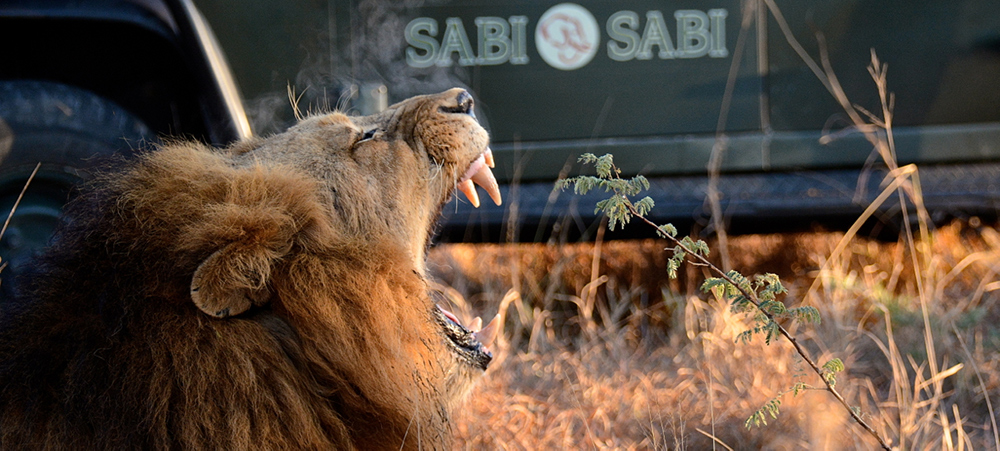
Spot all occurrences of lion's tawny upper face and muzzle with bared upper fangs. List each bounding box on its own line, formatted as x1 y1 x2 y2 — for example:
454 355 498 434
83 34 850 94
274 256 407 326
232 89 500 270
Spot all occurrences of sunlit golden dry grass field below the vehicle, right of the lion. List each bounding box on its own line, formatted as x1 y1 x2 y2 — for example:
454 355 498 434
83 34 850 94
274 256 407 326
429 219 1000 450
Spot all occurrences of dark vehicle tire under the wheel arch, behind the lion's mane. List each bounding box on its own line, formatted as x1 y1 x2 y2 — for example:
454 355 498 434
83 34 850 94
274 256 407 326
0 80 155 298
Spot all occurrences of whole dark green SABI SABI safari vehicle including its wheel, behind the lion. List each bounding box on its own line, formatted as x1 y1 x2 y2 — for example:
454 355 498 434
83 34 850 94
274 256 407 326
0 0 1000 290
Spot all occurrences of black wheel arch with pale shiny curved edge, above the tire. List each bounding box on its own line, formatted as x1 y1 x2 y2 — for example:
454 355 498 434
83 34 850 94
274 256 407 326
0 0 250 145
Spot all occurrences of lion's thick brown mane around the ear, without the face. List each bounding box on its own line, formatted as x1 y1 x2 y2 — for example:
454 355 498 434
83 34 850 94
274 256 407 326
0 145 452 449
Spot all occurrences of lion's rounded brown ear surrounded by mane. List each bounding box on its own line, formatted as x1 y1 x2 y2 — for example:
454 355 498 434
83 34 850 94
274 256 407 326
191 243 287 318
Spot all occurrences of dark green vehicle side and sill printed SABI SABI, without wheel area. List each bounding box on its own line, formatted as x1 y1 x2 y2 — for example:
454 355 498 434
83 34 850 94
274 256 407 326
199 0 1000 244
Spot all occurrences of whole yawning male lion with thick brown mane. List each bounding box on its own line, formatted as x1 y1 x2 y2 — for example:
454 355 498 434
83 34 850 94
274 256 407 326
0 89 501 450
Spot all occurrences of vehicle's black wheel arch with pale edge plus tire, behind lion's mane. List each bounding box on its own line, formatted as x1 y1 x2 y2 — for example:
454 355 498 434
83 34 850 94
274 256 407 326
0 0 250 293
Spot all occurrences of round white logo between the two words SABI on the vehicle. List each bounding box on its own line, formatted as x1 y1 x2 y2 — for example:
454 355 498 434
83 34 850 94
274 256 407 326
535 3 601 70
